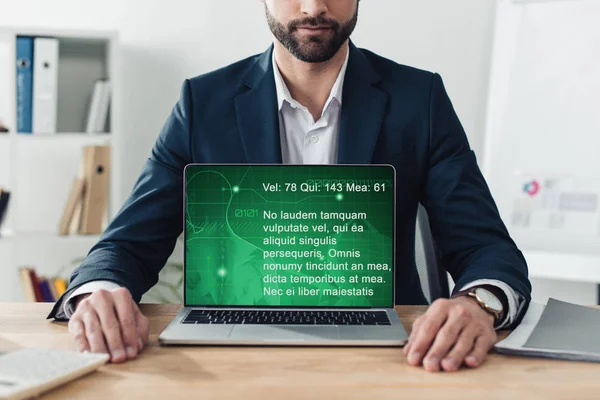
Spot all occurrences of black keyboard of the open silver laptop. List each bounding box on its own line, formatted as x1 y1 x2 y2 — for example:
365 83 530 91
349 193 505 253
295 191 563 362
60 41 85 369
182 310 391 325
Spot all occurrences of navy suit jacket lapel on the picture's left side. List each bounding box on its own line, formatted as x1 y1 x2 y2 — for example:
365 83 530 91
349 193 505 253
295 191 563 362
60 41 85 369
235 46 282 164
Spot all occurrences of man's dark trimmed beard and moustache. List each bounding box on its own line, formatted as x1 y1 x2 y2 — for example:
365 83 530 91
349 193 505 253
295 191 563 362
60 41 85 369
265 5 358 63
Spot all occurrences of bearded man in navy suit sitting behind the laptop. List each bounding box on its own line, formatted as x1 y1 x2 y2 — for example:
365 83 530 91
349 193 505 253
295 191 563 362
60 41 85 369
50 0 531 371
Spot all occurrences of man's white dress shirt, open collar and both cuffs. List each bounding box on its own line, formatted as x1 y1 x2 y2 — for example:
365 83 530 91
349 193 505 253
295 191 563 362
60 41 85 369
57 47 523 329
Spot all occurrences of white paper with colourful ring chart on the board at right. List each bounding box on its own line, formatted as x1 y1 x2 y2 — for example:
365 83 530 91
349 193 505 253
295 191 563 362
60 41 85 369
508 172 600 239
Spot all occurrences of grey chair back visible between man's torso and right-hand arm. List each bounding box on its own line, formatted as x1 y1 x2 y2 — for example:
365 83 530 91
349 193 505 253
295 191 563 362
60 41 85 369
415 204 450 304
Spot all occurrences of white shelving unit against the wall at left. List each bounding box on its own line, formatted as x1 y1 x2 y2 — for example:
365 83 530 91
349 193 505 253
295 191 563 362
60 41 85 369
0 28 123 301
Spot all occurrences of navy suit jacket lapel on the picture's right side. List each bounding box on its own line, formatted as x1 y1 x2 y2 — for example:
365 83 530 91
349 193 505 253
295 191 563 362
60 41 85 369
338 42 387 164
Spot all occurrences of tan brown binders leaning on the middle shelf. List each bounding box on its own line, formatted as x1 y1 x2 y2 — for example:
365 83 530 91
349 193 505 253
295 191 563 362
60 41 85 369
58 146 110 236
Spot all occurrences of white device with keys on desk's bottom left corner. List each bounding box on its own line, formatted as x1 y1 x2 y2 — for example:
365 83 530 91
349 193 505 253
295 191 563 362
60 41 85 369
0 349 109 399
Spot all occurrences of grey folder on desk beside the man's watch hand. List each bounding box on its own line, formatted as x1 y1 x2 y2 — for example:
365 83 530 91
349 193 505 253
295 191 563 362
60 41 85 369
495 299 600 362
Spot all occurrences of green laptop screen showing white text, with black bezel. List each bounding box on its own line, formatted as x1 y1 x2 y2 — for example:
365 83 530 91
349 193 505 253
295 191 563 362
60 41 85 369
184 164 395 308
